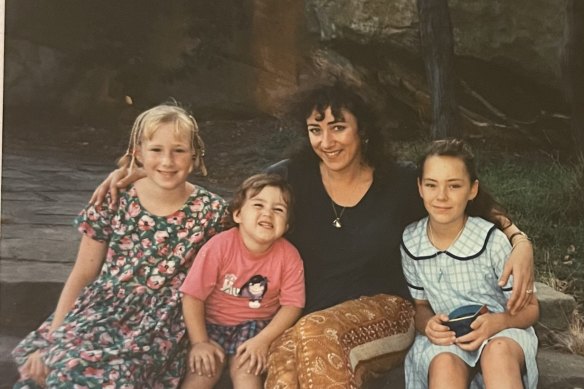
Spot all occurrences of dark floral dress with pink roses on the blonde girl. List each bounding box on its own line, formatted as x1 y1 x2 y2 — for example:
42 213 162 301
12 187 226 388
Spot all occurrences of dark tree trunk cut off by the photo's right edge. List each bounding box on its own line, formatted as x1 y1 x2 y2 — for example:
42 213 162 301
563 0 584 156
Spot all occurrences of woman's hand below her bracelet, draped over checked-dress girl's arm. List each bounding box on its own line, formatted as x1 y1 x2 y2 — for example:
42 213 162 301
499 239 534 315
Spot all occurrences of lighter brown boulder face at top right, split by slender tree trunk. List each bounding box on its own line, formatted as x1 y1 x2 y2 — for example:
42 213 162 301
306 0 567 89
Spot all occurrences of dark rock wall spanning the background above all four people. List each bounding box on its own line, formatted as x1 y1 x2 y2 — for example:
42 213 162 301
5 0 568 143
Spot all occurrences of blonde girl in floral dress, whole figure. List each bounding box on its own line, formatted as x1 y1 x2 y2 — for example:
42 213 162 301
13 105 226 388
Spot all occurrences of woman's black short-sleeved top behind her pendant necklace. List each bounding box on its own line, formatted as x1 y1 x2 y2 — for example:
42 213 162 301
270 158 425 313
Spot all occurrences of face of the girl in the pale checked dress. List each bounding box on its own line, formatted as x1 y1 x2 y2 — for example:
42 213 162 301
418 155 479 224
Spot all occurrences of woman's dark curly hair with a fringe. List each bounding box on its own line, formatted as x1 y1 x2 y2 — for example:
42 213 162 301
291 81 393 168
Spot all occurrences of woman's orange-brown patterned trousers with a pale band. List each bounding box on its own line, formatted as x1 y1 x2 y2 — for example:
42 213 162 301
266 295 414 389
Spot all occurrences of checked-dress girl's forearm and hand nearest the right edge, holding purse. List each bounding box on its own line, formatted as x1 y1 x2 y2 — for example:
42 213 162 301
456 294 539 351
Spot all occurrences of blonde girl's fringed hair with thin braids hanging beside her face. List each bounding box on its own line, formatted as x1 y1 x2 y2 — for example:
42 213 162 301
118 104 207 176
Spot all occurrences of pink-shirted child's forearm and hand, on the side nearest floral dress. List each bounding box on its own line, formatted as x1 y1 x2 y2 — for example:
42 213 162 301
182 294 225 377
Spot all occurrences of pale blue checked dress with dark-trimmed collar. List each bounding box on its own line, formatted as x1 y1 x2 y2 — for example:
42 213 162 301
401 217 538 389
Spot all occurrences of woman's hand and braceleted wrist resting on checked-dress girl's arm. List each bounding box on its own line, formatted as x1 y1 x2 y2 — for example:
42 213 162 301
492 218 535 315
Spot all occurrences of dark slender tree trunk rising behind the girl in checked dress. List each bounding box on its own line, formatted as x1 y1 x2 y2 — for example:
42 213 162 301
417 0 462 139
